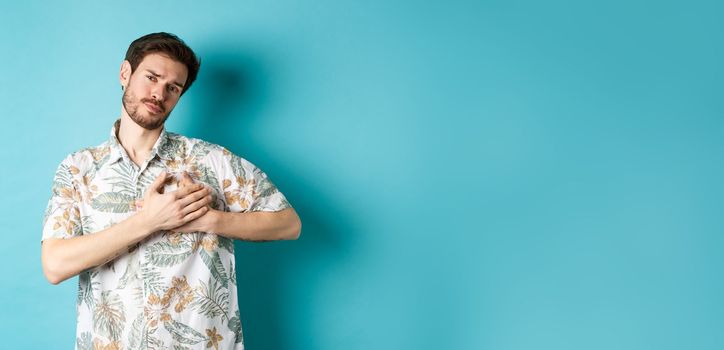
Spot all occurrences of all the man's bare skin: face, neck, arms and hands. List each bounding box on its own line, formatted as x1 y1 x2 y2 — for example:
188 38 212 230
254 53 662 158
41 54 301 284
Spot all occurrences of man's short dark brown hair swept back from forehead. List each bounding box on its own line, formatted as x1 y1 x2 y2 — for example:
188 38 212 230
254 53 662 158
126 32 201 95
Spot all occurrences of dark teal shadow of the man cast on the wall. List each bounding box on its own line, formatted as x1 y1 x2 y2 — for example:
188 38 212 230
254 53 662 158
189 49 352 350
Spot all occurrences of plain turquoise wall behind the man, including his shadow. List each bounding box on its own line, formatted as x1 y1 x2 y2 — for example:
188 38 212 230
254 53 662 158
0 0 724 350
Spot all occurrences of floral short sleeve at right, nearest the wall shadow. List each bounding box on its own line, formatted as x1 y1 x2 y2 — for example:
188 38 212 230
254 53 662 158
219 149 291 212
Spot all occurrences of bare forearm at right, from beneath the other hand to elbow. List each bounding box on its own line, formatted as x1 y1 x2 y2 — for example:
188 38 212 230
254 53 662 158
208 208 302 241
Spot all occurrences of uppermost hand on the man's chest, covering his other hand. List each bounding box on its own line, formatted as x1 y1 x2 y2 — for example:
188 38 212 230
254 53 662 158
138 171 211 232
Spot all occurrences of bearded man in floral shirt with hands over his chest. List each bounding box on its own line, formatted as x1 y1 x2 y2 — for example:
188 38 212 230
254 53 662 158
42 33 301 349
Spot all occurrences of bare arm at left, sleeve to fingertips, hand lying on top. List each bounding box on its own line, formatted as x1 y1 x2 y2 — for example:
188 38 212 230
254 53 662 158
41 173 211 284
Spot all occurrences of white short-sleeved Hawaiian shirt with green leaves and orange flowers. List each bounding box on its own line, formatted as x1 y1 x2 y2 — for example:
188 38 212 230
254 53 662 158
42 121 291 350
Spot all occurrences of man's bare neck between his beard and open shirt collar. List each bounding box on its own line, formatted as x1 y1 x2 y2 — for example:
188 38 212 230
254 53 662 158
116 113 163 164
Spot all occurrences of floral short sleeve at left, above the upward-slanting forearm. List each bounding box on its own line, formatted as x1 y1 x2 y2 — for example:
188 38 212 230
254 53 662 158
41 157 83 241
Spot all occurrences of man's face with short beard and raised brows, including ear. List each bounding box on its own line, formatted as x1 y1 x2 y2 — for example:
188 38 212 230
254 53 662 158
121 53 188 130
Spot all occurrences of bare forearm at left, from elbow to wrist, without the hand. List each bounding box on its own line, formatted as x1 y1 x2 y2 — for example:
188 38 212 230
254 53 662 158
41 214 152 284
